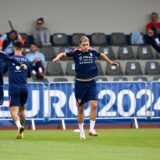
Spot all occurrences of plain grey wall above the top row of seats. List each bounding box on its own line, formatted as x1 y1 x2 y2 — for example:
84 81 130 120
0 0 160 34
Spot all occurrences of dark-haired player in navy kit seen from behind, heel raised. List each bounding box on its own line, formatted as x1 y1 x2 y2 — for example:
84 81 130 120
8 42 31 139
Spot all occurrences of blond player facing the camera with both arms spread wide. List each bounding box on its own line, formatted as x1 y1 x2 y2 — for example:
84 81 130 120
53 36 119 140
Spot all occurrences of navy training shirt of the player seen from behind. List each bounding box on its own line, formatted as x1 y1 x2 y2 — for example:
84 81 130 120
8 55 31 87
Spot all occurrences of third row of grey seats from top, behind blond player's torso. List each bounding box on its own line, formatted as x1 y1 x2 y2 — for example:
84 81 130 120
46 61 160 76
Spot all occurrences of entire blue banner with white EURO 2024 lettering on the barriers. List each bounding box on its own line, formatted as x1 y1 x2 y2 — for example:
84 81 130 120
0 82 160 119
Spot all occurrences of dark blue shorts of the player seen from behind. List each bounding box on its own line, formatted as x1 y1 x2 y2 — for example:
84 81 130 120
9 86 28 107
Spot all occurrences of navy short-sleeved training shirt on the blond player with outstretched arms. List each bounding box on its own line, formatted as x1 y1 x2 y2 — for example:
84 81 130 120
66 48 101 79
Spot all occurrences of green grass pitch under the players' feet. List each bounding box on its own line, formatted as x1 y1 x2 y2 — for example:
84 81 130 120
0 129 160 160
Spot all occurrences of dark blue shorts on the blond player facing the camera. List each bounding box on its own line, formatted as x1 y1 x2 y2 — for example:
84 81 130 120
75 80 97 105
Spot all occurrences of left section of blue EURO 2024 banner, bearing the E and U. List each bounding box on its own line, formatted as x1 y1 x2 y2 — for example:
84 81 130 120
0 83 44 119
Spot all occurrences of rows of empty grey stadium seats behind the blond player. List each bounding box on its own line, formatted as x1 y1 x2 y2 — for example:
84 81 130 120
5 32 160 82
